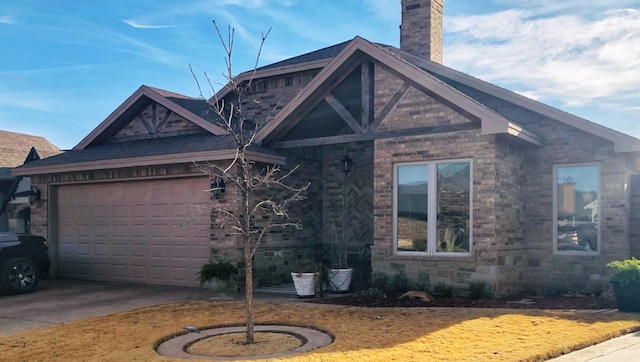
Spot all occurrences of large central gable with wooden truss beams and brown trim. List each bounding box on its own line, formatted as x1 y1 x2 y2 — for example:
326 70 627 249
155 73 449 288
257 37 542 148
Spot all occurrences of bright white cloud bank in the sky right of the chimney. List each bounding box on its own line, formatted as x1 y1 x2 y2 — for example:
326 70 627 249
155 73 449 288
445 7 640 106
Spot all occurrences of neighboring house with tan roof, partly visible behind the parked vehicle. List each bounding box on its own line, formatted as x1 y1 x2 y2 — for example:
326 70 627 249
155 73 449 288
0 130 61 232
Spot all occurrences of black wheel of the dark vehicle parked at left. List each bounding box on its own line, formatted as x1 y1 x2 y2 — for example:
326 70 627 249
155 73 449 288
0 258 40 294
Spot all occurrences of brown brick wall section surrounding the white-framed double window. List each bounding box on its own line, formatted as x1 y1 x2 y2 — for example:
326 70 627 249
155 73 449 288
372 130 508 293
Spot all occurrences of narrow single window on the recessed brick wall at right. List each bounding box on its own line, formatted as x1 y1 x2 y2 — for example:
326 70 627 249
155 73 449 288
553 164 600 254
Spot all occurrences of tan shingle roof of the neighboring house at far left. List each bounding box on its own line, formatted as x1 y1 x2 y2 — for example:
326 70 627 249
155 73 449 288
0 130 62 167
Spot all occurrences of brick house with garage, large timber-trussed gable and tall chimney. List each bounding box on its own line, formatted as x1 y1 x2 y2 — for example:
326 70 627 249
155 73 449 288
13 0 640 296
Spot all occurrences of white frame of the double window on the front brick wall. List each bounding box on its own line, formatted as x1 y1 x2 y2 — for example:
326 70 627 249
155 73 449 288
392 158 473 257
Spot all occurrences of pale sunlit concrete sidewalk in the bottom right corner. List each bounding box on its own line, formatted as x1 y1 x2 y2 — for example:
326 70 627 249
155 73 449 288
549 332 640 362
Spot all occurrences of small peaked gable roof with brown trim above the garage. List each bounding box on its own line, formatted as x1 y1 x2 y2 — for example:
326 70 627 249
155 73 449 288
73 85 227 150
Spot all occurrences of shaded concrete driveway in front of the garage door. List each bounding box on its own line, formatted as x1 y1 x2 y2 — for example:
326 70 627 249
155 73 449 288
0 279 228 336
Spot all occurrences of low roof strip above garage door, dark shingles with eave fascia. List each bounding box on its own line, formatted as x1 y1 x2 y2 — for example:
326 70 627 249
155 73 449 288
12 133 285 175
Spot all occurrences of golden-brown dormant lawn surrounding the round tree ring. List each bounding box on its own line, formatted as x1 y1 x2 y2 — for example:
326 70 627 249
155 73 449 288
0 301 640 362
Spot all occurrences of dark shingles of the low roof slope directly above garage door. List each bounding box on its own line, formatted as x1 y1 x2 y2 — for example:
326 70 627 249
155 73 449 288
15 134 278 169
